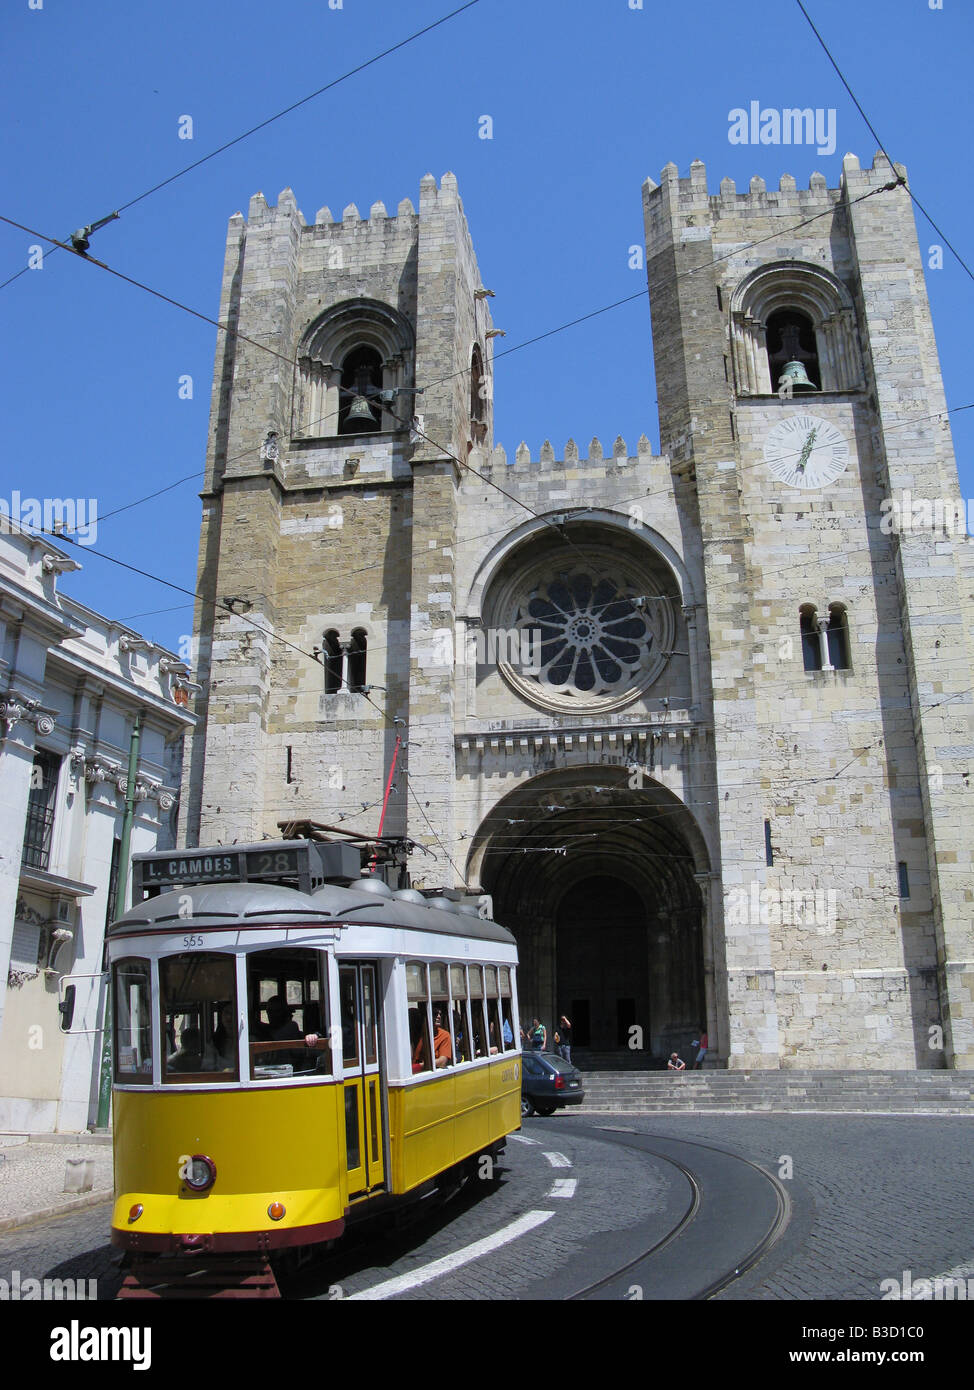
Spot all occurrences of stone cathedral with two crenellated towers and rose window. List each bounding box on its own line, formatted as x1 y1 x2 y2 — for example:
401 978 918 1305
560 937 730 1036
181 156 974 1069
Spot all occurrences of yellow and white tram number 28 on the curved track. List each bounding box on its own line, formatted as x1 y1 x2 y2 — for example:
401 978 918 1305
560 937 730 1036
108 840 521 1286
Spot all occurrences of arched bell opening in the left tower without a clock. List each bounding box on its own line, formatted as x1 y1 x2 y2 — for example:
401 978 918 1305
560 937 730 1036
292 299 415 439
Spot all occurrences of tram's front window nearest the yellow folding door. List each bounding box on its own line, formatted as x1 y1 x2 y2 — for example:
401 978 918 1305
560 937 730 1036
247 947 332 1081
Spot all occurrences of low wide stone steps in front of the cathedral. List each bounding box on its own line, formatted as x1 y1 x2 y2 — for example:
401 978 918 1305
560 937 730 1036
575 1070 974 1115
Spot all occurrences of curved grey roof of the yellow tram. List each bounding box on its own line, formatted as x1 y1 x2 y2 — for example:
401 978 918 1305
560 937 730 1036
108 883 515 945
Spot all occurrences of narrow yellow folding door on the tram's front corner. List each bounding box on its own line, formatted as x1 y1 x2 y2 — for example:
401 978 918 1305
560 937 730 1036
339 962 385 1201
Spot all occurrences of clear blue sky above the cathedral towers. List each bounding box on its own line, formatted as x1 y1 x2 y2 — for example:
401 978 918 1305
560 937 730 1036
0 0 974 648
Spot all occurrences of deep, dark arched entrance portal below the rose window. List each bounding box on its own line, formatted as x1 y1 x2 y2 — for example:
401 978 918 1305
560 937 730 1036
468 767 720 1065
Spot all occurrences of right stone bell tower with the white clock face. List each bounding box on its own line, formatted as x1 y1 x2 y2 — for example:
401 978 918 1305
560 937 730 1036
643 154 974 1068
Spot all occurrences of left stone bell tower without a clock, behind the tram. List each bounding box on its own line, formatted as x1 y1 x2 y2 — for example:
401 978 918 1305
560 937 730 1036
181 174 492 883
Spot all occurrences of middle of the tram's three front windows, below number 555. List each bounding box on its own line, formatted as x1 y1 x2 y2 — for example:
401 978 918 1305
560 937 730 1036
158 951 239 1084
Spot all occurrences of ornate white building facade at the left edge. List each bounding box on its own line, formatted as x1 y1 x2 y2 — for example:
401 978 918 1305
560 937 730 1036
0 521 193 1133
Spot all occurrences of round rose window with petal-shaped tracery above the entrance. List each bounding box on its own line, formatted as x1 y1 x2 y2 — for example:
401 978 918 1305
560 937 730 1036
515 570 656 696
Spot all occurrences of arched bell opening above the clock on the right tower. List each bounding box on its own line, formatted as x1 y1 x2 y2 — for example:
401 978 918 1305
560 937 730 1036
731 261 863 396
